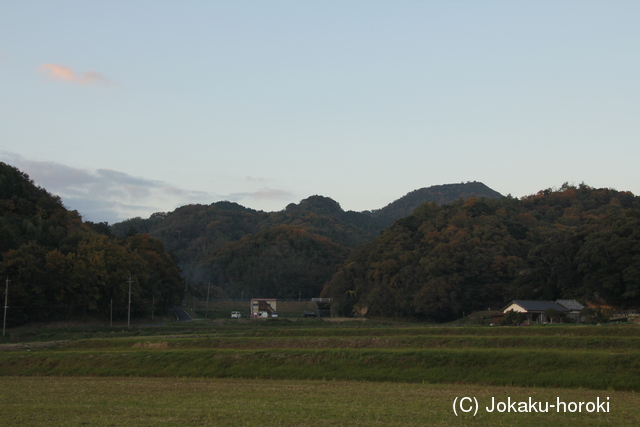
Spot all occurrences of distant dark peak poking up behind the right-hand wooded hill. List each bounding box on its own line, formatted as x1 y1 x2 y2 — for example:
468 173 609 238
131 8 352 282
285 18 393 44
372 181 503 220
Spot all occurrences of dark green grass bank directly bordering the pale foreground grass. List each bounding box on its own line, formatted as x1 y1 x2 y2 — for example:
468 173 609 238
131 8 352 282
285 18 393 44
0 349 640 391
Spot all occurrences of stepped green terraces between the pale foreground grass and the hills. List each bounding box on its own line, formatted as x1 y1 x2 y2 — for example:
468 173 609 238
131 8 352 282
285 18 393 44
0 323 640 391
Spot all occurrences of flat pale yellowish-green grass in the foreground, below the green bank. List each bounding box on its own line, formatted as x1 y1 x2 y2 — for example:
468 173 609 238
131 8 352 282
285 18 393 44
0 377 640 426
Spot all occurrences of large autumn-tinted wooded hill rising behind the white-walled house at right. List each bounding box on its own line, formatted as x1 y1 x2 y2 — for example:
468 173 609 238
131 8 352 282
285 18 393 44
323 184 640 321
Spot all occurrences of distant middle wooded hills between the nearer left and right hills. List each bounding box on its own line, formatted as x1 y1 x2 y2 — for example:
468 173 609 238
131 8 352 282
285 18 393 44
111 183 498 298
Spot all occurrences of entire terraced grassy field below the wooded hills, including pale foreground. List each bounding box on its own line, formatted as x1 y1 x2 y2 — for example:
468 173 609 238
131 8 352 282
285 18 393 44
0 318 640 425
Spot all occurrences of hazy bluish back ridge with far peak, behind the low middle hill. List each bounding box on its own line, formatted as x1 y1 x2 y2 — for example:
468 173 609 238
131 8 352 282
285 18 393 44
111 182 499 294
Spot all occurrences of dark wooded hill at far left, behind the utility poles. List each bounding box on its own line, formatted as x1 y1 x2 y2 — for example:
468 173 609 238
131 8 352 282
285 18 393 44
0 162 184 325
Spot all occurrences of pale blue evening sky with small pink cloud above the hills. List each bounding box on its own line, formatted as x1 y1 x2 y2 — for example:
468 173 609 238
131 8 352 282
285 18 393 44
0 0 640 223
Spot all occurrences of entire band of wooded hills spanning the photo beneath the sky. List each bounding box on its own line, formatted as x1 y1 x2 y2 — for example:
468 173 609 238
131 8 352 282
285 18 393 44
5 163 640 324
